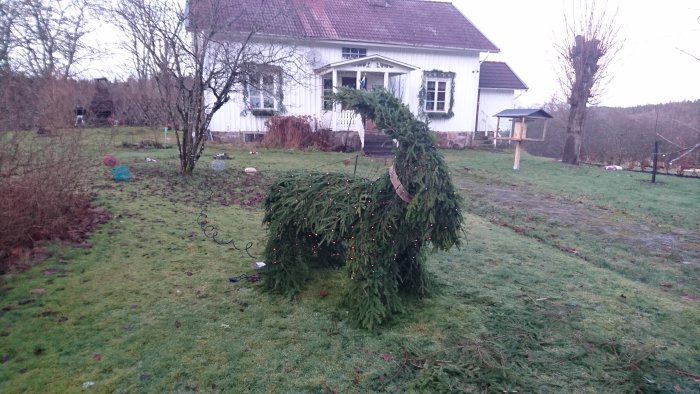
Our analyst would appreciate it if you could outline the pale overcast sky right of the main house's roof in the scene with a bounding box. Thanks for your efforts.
[451,0,700,107]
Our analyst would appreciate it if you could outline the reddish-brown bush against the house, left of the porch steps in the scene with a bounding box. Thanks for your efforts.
[262,116,331,150]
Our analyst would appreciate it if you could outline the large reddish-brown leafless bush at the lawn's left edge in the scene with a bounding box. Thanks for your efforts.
[0,132,107,273]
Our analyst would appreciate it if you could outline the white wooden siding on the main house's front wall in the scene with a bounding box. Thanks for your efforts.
[210,43,482,133]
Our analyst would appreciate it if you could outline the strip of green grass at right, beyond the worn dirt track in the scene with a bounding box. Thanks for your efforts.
[446,151,700,229]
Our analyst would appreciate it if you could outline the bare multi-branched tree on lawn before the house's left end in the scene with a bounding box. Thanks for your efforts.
[112,0,300,174]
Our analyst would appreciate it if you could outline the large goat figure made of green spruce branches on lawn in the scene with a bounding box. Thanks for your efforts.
[263,89,462,329]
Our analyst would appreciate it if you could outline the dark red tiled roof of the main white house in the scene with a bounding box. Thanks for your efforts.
[190,0,498,52]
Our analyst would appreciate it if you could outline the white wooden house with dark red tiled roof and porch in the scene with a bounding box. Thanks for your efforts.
[200,0,524,148]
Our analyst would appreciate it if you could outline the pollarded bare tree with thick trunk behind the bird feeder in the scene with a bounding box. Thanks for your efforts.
[558,0,622,164]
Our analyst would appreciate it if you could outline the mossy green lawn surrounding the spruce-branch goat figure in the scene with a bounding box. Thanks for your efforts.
[0,131,700,393]
